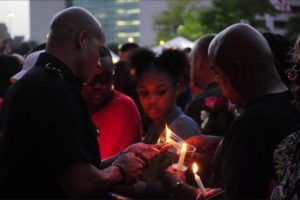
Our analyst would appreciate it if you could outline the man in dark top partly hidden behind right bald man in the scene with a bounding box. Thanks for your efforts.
[184,34,236,136]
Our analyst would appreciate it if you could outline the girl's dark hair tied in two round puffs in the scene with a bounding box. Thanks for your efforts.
[129,48,189,83]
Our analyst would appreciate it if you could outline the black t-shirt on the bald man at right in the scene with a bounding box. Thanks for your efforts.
[211,92,299,199]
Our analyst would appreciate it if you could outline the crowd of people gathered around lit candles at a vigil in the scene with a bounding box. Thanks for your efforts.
[0,7,300,200]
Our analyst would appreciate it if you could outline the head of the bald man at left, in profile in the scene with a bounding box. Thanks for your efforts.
[46,7,105,81]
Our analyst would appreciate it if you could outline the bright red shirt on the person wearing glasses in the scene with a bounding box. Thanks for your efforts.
[92,90,142,159]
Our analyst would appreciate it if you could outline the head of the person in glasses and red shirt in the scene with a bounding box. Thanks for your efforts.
[81,47,114,112]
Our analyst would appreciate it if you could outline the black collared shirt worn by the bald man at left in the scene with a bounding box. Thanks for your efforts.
[0,53,100,198]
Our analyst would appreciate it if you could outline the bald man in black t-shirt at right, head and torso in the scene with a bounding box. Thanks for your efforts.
[208,24,299,198]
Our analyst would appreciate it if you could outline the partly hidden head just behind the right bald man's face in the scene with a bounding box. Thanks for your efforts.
[190,34,215,89]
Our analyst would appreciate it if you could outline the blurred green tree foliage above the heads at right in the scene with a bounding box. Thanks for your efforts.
[154,0,277,40]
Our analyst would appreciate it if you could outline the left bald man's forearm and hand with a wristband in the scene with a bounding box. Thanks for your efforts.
[59,153,145,198]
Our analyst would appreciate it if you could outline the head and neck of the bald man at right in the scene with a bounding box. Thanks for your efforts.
[208,23,287,107]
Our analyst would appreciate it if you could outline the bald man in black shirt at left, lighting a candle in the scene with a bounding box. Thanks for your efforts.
[0,7,158,199]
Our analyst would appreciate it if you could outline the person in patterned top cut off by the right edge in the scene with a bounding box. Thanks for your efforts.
[271,33,300,200]
